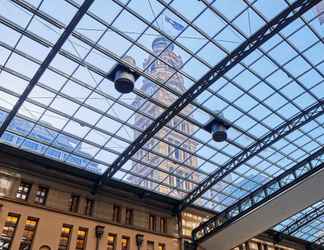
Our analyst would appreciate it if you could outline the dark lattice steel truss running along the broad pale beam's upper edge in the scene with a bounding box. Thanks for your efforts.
[192,147,324,243]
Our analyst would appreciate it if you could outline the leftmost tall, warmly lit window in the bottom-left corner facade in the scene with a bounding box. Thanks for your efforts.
[0,213,20,250]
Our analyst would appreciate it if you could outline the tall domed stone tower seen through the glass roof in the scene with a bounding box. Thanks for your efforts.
[128,37,198,198]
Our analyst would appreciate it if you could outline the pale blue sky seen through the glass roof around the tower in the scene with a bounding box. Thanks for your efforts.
[0,0,324,215]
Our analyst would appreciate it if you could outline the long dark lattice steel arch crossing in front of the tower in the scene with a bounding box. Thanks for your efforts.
[93,0,320,193]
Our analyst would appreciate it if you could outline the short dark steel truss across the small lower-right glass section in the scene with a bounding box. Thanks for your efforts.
[281,205,324,235]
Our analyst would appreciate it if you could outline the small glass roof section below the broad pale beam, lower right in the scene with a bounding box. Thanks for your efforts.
[274,200,324,244]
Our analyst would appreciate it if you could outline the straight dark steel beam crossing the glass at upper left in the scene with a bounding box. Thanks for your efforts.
[0,0,94,137]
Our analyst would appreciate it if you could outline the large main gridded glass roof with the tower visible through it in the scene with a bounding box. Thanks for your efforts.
[0,0,324,218]
